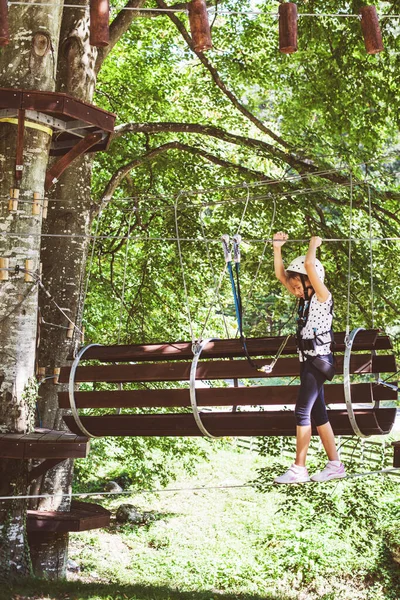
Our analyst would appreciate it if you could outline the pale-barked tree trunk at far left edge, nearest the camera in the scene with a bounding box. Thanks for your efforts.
[0,0,61,581]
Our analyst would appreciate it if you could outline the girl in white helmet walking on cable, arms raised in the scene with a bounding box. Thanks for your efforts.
[273,231,346,483]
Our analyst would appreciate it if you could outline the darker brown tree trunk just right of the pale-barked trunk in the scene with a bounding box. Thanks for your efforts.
[31,1,96,578]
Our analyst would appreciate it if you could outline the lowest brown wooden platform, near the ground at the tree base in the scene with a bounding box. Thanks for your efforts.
[26,500,111,534]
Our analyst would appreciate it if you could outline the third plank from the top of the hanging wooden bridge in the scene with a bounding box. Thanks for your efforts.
[58,383,397,408]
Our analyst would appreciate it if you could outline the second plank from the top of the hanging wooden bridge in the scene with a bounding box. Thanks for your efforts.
[59,354,396,383]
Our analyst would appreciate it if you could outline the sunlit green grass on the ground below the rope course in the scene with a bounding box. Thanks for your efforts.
[5,442,400,600]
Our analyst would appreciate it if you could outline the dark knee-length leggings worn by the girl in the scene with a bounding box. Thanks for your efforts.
[294,354,333,427]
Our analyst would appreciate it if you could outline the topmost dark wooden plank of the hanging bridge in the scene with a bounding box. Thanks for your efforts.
[69,329,392,362]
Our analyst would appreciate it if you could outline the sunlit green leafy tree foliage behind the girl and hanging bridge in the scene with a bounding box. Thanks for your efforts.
[78,0,400,502]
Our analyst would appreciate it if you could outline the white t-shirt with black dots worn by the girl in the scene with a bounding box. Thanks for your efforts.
[299,294,333,361]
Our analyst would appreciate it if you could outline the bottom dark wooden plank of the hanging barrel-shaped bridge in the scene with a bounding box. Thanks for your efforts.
[64,408,396,436]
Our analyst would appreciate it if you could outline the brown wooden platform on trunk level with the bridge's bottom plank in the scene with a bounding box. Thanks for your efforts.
[0,429,90,459]
